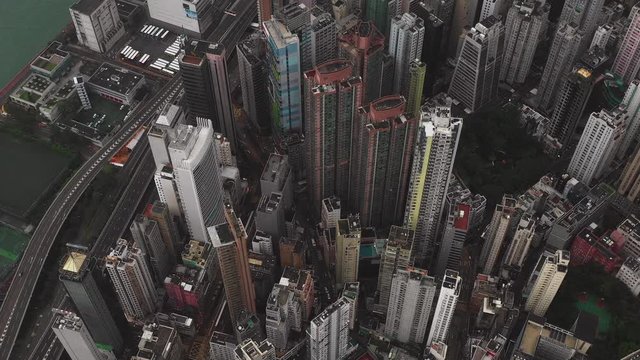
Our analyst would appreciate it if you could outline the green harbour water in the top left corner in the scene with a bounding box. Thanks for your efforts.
[0,0,75,88]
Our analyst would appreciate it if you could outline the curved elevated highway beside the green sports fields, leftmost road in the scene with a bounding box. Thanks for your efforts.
[0,73,182,359]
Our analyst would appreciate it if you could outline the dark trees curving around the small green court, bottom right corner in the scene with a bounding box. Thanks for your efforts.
[547,264,640,360]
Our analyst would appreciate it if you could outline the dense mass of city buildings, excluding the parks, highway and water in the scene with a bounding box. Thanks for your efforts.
[11,0,640,360]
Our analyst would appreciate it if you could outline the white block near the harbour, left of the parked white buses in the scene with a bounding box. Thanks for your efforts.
[69,0,124,53]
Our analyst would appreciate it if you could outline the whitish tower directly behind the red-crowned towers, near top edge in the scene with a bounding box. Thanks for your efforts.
[389,13,424,96]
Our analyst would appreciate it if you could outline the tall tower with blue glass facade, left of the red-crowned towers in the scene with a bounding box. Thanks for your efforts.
[262,20,303,135]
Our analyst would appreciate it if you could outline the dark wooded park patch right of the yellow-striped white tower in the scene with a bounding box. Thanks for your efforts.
[455,104,551,204]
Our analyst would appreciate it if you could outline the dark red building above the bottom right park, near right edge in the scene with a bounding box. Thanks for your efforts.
[570,224,623,273]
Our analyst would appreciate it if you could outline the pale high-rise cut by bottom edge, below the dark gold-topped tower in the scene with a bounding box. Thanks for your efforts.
[52,309,116,360]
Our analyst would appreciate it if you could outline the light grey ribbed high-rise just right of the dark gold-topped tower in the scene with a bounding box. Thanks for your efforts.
[105,239,157,322]
